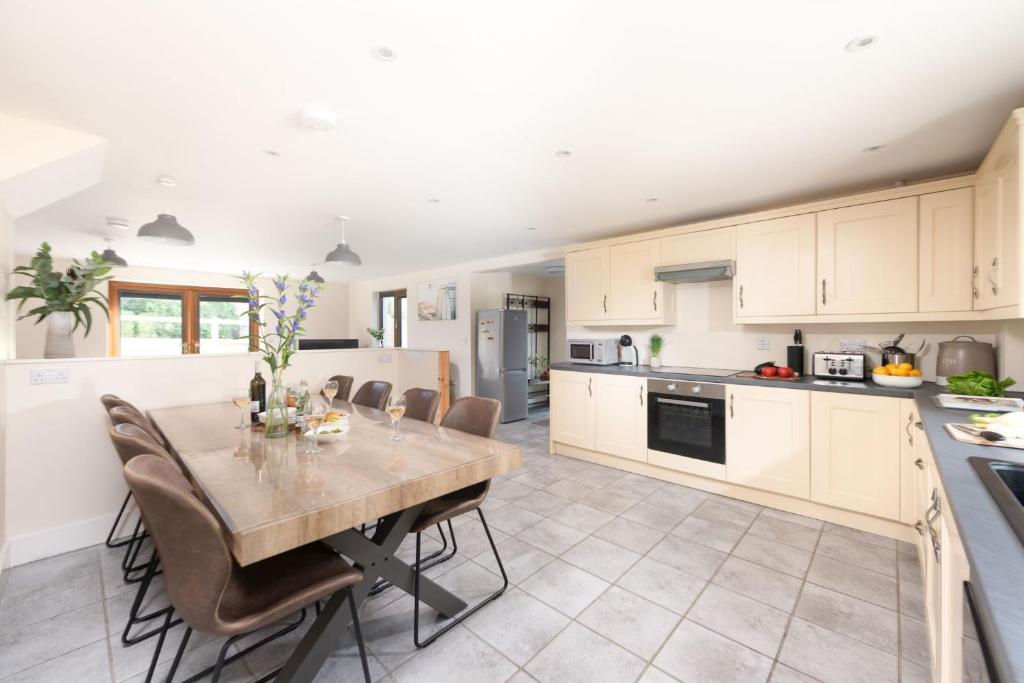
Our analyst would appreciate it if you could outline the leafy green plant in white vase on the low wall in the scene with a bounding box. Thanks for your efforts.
[6,242,113,358]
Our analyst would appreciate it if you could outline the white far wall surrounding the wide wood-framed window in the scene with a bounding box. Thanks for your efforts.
[14,254,348,358]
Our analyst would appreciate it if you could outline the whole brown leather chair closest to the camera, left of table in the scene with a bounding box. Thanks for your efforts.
[125,455,370,683]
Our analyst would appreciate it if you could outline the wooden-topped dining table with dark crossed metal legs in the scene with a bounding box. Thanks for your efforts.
[150,400,522,682]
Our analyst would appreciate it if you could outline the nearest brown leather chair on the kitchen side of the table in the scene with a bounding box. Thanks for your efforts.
[410,396,509,647]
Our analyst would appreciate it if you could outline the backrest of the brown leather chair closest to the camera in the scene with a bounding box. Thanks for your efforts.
[125,455,234,635]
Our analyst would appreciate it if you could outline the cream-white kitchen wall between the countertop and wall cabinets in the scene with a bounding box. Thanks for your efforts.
[567,281,1003,384]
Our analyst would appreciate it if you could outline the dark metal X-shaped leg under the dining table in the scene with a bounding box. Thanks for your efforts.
[275,505,466,683]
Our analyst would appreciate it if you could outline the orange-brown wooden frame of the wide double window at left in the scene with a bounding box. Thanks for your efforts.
[106,281,259,356]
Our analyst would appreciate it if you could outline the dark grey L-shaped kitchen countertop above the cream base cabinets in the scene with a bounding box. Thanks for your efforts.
[551,362,1024,682]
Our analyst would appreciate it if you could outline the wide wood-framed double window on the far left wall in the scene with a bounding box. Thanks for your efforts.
[108,282,256,356]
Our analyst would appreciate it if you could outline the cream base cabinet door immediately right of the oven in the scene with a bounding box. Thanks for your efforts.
[725,385,812,499]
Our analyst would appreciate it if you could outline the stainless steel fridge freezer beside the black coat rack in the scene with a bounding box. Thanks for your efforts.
[476,309,527,422]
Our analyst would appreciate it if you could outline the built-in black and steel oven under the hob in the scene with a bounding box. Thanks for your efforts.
[647,379,725,465]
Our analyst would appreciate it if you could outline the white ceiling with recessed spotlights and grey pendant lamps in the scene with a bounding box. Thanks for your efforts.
[0,0,1024,280]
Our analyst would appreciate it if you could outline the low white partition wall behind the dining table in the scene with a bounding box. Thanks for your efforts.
[0,349,438,564]
